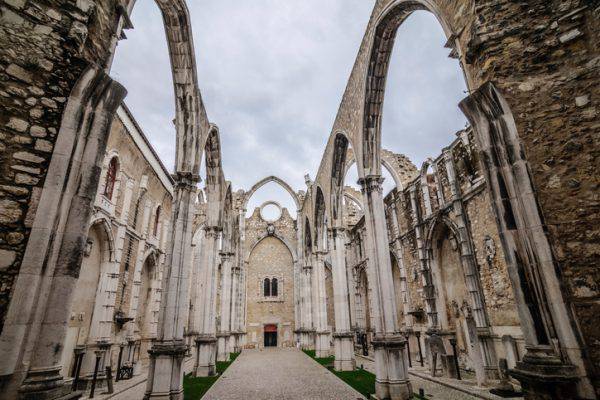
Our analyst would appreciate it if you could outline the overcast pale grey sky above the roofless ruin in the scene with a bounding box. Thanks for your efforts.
[112,0,465,214]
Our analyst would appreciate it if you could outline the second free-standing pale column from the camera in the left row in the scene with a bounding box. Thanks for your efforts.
[194,226,221,376]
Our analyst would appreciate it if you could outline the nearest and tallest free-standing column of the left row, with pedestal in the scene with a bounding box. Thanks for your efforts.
[144,173,195,400]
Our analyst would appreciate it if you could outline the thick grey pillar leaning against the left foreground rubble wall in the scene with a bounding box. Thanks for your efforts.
[9,68,126,400]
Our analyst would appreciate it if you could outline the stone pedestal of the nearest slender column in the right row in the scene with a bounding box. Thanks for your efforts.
[372,335,412,400]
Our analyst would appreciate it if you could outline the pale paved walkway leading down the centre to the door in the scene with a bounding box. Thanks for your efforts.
[202,349,364,400]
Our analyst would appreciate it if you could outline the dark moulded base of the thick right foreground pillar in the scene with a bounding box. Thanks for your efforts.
[509,347,580,400]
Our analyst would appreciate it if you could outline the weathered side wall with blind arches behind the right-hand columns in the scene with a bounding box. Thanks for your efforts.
[347,129,525,380]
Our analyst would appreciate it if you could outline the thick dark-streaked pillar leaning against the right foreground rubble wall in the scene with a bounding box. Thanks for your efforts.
[460,82,595,400]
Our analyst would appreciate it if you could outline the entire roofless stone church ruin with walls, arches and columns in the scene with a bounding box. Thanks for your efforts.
[0,0,600,399]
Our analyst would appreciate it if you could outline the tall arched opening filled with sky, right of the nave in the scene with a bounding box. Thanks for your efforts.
[381,10,467,167]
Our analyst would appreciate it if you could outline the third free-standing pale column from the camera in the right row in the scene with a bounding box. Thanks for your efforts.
[312,251,330,358]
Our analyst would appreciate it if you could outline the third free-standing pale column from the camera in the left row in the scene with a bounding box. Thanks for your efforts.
[217,252,234,361]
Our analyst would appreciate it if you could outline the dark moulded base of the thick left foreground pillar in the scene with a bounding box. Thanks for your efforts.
[19,366,83,400]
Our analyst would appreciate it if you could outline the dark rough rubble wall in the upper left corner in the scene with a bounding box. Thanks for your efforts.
[0,0,116,331]
